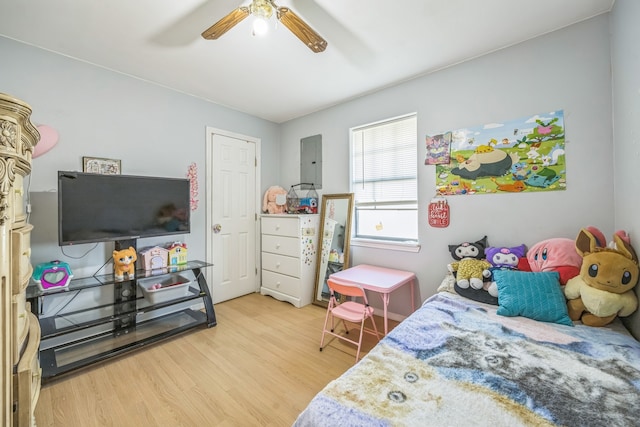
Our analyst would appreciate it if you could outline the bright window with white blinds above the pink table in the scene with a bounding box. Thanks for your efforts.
[351,114,418,243]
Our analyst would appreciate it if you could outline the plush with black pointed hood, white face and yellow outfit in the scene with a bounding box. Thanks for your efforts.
[447,236,491,289]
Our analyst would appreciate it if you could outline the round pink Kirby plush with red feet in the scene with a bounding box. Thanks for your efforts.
[518,237,582,285]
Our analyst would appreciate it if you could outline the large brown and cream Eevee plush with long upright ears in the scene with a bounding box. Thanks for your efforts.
[564,229,640,326]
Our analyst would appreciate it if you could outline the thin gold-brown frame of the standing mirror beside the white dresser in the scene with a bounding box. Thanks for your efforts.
[313,193,353,307]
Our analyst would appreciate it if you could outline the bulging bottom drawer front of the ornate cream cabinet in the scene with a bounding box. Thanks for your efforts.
[14,313,42,426]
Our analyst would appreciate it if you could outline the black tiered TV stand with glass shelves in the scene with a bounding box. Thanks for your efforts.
[26,261,217,382]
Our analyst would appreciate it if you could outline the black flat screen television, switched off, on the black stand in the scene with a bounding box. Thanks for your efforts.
[58,171,191,246]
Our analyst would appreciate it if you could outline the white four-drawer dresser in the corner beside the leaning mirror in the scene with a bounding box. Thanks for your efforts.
[260,214,319,308]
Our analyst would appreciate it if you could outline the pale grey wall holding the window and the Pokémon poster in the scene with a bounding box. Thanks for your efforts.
[282,15,614,314]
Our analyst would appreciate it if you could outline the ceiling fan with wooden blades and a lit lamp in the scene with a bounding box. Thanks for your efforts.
[202,0,327,53]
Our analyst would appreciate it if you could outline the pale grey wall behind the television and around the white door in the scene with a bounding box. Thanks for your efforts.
[0,37,280,274]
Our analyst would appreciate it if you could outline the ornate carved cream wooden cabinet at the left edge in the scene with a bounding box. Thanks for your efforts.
[0,93,41,426]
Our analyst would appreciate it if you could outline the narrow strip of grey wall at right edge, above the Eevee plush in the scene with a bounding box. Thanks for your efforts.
[610,0,640,339]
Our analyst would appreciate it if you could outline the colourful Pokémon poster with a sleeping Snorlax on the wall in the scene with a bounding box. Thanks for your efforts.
[436,110,567,195]
